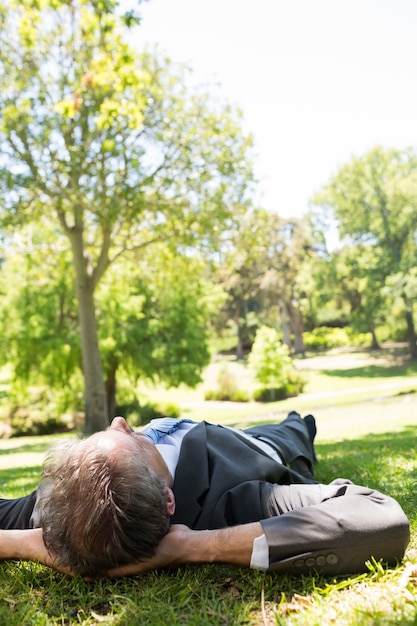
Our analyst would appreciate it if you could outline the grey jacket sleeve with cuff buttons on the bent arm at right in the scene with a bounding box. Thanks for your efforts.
[261,479,410,575]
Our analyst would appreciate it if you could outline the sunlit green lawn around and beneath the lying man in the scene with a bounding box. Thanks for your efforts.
[0,346,417,626]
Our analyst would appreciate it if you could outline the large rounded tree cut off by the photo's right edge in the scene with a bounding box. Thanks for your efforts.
[313,147,417,358]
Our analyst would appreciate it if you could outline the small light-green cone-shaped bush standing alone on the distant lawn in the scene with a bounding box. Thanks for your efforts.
[248,326,305,401]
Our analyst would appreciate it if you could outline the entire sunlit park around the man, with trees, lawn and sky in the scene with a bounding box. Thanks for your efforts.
[0,0,417,624]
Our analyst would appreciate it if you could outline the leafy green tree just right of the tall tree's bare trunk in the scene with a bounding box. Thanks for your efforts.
[97,244,216,415]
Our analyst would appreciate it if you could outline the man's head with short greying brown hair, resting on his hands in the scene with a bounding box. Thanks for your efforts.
[35,418,175,576]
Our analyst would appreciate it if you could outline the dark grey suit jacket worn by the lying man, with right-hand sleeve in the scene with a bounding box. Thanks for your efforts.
[172,414,409,575]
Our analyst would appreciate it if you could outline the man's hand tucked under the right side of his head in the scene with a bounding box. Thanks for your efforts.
[107,524,196,577]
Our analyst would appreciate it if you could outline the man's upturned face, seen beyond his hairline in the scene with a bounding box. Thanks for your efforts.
[89,417,172,487]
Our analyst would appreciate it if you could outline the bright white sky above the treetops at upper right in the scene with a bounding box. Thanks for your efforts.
[138,0,417,217]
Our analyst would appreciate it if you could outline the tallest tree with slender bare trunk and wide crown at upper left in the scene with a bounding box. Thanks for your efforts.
[0,0,252,432]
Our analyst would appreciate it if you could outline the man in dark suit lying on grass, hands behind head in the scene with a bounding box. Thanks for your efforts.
[0,412,409,577]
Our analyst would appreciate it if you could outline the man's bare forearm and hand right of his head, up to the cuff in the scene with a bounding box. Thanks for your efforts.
[108,522,264,576]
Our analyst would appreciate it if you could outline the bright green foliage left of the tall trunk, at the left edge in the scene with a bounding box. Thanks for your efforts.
[0,223,82,410]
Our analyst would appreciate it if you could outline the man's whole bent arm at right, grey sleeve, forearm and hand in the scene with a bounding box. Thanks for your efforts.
[109,481,409,576]
